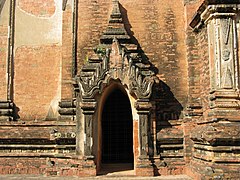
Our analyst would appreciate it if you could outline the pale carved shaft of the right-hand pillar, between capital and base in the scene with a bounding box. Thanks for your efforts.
[213,17,238,89]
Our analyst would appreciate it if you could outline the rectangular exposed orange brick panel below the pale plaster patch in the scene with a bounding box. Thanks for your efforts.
[14,45,61,120]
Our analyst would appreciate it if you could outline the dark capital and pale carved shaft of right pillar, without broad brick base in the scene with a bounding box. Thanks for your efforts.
[190,0,240,115]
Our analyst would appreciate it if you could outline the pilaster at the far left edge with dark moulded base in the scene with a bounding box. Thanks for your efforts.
[0,0,16,121]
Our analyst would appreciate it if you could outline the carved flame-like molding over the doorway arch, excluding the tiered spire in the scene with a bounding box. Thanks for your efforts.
[75,38,157,99]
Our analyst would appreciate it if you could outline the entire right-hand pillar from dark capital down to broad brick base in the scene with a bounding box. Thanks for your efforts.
[190,0,240,179]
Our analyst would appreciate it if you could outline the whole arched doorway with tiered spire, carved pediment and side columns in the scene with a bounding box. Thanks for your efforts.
[74,1,159,175]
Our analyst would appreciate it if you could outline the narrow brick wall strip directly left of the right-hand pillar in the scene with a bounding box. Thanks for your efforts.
[182,0,205,179]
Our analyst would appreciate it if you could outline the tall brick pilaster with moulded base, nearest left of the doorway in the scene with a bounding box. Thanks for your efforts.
[59,0,78,121]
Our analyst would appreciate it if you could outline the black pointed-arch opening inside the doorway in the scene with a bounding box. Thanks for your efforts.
[102,89,133,165]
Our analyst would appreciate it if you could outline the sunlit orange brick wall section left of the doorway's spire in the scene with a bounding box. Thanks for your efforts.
[77,0,112,70]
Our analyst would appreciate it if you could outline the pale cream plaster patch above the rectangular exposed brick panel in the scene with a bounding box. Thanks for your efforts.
[15,0,62,48]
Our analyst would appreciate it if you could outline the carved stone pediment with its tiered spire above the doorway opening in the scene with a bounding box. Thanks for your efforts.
[76,0,157,99]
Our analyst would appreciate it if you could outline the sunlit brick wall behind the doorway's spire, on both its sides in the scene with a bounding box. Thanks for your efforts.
[78,0,188,106]
